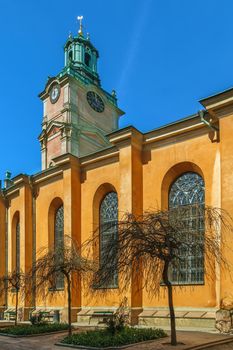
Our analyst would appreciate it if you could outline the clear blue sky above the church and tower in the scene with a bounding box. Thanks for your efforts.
[0,0,233,179]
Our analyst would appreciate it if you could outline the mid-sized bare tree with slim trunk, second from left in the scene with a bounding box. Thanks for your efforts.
[34,236,96,335]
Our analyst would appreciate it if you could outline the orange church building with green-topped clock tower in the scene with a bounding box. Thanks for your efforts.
[0,19,233,329]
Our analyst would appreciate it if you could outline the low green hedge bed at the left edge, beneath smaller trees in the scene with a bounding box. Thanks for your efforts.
[0,323,68,335]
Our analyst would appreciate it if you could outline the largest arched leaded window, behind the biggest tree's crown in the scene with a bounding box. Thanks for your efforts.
[169,172,205,284]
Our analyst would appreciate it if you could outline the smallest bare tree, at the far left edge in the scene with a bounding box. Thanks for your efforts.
[0,270,26,326]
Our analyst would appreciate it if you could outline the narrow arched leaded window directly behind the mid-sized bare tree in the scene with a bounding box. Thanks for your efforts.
[54,205,64,289]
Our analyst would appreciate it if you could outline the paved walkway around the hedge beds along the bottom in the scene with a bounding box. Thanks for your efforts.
[0,331,233,350]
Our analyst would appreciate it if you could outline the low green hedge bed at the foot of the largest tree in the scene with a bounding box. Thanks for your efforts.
[62,327,166,348]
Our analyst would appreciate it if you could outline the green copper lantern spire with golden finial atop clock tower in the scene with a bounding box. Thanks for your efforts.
[64,16,100,86]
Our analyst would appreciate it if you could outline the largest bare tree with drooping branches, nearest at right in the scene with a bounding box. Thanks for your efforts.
[86,205,233,345]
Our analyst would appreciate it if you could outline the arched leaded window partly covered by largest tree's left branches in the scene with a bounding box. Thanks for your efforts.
[100,192,118,288]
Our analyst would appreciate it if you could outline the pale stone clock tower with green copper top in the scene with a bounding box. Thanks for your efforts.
[39,17,124,170]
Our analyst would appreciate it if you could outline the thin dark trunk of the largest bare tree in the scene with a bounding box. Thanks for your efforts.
[163,261,177,345]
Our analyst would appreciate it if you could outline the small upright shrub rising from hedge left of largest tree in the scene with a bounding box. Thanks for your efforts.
[106,297,129,335]
